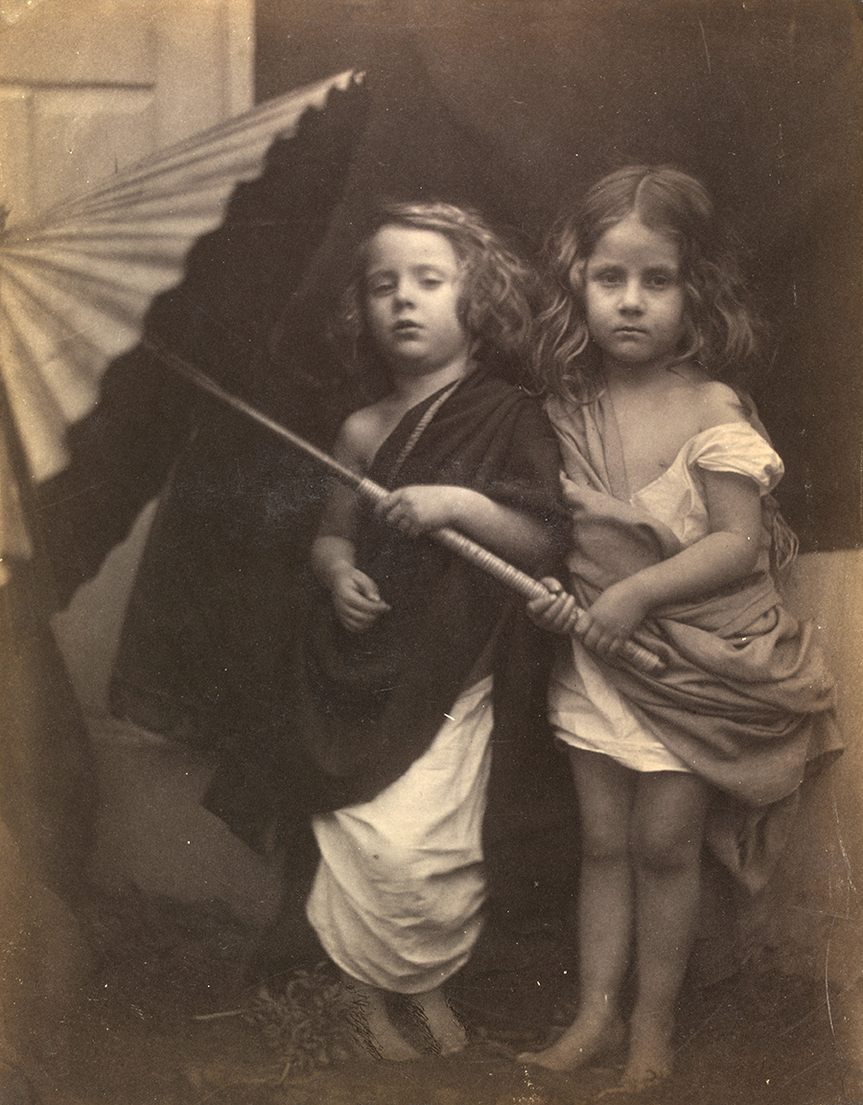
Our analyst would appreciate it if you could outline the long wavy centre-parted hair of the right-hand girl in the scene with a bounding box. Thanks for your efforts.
[530,165,765,402]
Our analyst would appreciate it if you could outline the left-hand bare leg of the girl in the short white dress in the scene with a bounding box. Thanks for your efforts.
[518,748,635,1071]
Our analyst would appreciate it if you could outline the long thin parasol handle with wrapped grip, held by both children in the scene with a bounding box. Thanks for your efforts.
[154,348,665,674]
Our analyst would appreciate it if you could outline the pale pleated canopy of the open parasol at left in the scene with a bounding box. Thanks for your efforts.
[0,72,359,581]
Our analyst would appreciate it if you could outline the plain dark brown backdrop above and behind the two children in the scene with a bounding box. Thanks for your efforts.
[256,0,863,550]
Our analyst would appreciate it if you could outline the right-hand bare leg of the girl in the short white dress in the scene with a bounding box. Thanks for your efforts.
[622,771,709,1091]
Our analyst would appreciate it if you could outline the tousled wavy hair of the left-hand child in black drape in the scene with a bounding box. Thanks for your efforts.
[329,201,538,380]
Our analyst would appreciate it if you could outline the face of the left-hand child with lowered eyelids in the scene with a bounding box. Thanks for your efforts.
[365,225,471,371]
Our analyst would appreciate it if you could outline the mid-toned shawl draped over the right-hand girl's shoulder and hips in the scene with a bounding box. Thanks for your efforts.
[551,397,841,888]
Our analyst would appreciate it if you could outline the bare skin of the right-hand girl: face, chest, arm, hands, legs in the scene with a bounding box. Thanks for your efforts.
[519,214,761,1091]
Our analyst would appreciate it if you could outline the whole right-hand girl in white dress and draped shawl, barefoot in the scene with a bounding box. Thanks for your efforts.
[520,166,836,1091]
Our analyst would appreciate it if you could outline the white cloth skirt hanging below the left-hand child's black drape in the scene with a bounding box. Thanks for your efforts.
[306,676,492,993]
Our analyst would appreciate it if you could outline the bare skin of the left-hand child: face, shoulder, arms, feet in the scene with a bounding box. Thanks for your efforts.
[312,219,551,1060]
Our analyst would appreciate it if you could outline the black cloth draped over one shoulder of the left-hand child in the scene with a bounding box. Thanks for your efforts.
[235,369,577,985]
